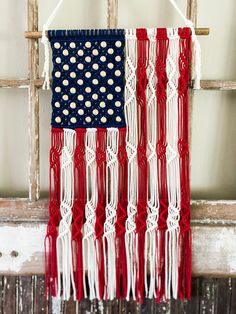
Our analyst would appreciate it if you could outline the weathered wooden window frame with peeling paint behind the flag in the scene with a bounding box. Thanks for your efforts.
[0,0,236,276]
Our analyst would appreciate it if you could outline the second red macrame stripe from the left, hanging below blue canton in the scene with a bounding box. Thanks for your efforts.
[72,128,86,301]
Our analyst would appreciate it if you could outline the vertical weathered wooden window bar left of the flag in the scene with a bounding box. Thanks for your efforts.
[28,0,39,201]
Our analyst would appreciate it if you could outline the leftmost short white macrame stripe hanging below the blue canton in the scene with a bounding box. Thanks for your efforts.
[56,129,76,300]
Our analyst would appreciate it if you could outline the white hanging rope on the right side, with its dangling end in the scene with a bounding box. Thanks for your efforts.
[169,0,202,89]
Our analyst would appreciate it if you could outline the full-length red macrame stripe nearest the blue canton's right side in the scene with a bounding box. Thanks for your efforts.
[136,29,149,303]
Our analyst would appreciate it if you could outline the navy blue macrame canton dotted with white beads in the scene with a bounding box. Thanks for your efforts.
[48,30,125,128]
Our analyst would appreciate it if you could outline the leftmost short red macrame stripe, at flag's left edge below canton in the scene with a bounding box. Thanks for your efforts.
[44,128,63,296]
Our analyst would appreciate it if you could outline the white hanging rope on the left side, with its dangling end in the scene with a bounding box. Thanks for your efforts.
[41,0,63,89]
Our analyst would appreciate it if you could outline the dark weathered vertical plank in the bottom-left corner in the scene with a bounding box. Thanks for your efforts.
[2,276,17,314]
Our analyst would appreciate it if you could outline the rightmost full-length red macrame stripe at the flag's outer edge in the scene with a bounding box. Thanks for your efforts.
[178,28,191,299]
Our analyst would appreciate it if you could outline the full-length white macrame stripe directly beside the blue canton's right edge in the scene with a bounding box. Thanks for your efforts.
[124,29,138,300]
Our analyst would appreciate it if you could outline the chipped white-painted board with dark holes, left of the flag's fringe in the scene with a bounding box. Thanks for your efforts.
[0,224,46,274]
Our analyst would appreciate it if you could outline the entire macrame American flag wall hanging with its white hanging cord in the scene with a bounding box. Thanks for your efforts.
[42,0,200,302]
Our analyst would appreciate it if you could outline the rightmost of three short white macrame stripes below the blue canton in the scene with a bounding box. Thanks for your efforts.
[103,128,119,300]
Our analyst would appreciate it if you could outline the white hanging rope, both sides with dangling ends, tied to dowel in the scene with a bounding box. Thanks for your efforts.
[41,0,201,89]
